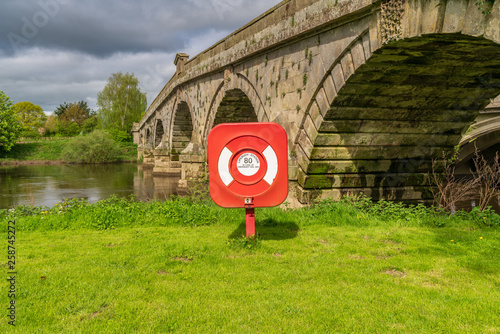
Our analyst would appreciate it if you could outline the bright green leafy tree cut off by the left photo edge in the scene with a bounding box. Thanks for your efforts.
[0,91,22,151]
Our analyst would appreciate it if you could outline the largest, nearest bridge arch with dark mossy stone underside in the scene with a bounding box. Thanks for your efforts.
[297,33,500,200]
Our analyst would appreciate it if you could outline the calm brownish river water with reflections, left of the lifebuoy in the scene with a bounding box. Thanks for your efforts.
[0,164,179,209]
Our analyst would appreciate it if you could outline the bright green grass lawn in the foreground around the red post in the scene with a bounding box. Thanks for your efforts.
[0,198,500,333]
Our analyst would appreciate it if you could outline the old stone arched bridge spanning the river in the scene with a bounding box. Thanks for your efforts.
[134,0,500,203]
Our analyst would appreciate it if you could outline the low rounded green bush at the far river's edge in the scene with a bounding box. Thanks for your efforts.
[62,131,121,164]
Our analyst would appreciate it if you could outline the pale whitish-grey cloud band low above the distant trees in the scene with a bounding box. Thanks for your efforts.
[0,49,180,111]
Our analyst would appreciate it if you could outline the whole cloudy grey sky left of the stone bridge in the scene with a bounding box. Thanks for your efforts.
[0,0,280,113]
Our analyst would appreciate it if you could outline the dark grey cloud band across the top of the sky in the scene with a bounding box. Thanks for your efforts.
[0,0,278,57]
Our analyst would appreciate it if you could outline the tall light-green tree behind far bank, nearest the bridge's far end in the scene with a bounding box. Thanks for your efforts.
[97,72,147,133]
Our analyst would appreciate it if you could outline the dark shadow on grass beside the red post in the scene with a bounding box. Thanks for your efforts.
[229,218,299,240]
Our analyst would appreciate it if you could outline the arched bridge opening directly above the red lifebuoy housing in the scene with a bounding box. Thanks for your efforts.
[213,89,258,126]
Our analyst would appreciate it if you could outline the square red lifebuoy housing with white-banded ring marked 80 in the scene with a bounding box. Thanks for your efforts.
[208,123,288,207]
